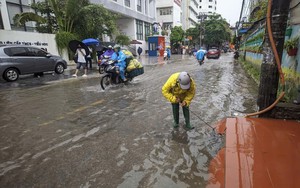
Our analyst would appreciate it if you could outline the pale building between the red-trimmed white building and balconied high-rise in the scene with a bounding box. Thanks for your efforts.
[182,0,199,30]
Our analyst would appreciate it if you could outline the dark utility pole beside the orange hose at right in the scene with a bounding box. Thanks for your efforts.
[257,0,291,117]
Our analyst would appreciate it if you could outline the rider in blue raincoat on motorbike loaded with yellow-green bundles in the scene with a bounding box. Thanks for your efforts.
[111,45,127,81]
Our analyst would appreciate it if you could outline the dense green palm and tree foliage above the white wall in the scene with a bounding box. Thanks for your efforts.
[15,0,117,54]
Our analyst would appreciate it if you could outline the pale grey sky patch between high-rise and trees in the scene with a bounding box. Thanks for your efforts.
[217,0,243,26]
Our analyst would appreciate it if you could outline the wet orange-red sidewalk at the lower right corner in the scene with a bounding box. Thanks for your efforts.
[207,117,300,188]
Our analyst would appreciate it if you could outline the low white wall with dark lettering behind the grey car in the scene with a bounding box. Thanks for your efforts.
[0,30,69,61]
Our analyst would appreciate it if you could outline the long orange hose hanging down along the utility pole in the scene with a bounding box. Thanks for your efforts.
[245,0,285,117]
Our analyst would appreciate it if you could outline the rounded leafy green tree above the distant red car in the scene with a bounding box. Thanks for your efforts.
[202,14,231,46]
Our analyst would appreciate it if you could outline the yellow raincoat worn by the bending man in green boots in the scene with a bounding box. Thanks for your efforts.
[162,72,196,106]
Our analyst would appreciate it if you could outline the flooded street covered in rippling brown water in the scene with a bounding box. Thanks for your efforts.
[0,54,257,188]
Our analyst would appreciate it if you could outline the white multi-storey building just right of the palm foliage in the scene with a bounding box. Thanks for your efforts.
[90,0,156,53]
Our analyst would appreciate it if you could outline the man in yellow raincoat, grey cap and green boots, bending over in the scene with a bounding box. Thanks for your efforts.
[162,72,196,129]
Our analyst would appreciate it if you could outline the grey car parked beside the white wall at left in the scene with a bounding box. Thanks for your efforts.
[0,45,67,82]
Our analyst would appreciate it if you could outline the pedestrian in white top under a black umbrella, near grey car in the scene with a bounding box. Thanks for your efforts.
[69,40,89,77]
